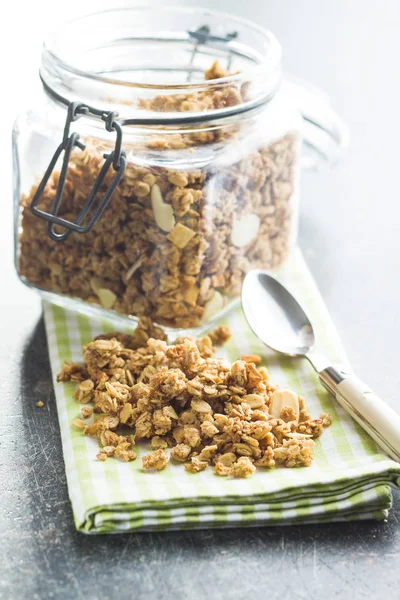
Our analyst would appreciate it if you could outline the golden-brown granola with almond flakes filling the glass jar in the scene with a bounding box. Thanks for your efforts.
[19,59,298,329]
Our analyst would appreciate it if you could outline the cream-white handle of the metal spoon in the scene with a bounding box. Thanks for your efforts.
[319,367,400,462]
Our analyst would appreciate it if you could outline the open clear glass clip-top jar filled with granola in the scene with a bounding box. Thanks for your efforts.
[13,8,346,331]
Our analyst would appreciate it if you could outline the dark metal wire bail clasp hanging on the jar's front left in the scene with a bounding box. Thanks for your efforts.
[31,102,126,242]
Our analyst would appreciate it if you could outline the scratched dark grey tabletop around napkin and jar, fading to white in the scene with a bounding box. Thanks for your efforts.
[0,0,400,600]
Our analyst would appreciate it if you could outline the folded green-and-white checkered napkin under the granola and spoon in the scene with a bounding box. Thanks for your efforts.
[44,251,400,533]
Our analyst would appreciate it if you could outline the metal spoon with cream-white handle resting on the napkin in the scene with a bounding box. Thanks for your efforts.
[242,269,400,462]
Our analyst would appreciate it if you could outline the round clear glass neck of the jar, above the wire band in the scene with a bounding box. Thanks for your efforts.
[40,8,281,124]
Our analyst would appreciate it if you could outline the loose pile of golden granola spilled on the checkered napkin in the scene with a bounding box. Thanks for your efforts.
[58,319,331,477]
